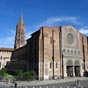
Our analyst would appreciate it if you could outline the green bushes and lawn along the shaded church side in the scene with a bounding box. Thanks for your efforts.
[0,68,36,81]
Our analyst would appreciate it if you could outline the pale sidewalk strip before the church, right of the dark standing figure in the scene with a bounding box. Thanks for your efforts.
[17,77,88,86]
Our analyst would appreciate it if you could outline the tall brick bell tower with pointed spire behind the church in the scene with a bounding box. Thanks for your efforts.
[14,14,26,49]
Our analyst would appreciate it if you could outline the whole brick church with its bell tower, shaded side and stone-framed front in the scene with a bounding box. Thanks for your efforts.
[7,17,88,80]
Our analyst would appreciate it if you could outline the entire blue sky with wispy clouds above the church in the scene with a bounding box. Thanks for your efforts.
[0,0,88,48]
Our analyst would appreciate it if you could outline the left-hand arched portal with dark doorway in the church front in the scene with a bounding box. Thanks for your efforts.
[66,60,73,77]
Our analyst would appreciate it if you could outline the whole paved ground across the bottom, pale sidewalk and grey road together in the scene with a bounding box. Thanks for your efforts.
[0,77,88,88]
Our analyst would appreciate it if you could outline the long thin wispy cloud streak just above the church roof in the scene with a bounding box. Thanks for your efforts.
[35,17,81,28]
